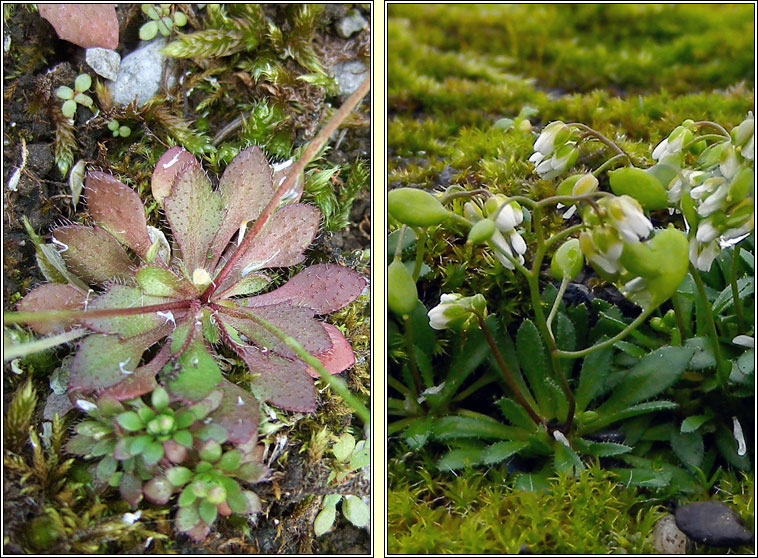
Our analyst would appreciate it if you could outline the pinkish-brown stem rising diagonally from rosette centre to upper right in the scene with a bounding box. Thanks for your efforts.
[200,78,371,304]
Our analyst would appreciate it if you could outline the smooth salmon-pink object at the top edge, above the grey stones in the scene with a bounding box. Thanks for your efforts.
[37,3,118,50]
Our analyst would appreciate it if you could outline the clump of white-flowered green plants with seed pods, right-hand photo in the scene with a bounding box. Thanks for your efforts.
[388,113,754,479]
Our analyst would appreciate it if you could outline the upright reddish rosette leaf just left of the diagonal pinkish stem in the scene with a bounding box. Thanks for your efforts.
[211,146,274,266]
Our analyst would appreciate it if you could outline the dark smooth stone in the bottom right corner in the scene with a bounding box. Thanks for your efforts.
[676,501,753,547]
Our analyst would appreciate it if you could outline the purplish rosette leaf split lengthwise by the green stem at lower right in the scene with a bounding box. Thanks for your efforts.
[218,304,331,358]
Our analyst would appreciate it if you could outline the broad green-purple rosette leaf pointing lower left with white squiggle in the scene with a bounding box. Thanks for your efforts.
[68,325,171,392]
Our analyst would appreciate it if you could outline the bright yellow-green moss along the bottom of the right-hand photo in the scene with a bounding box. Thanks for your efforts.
[388,462,664,555]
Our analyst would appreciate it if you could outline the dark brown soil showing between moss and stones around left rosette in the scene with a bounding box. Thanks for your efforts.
[3,5,371,554]
